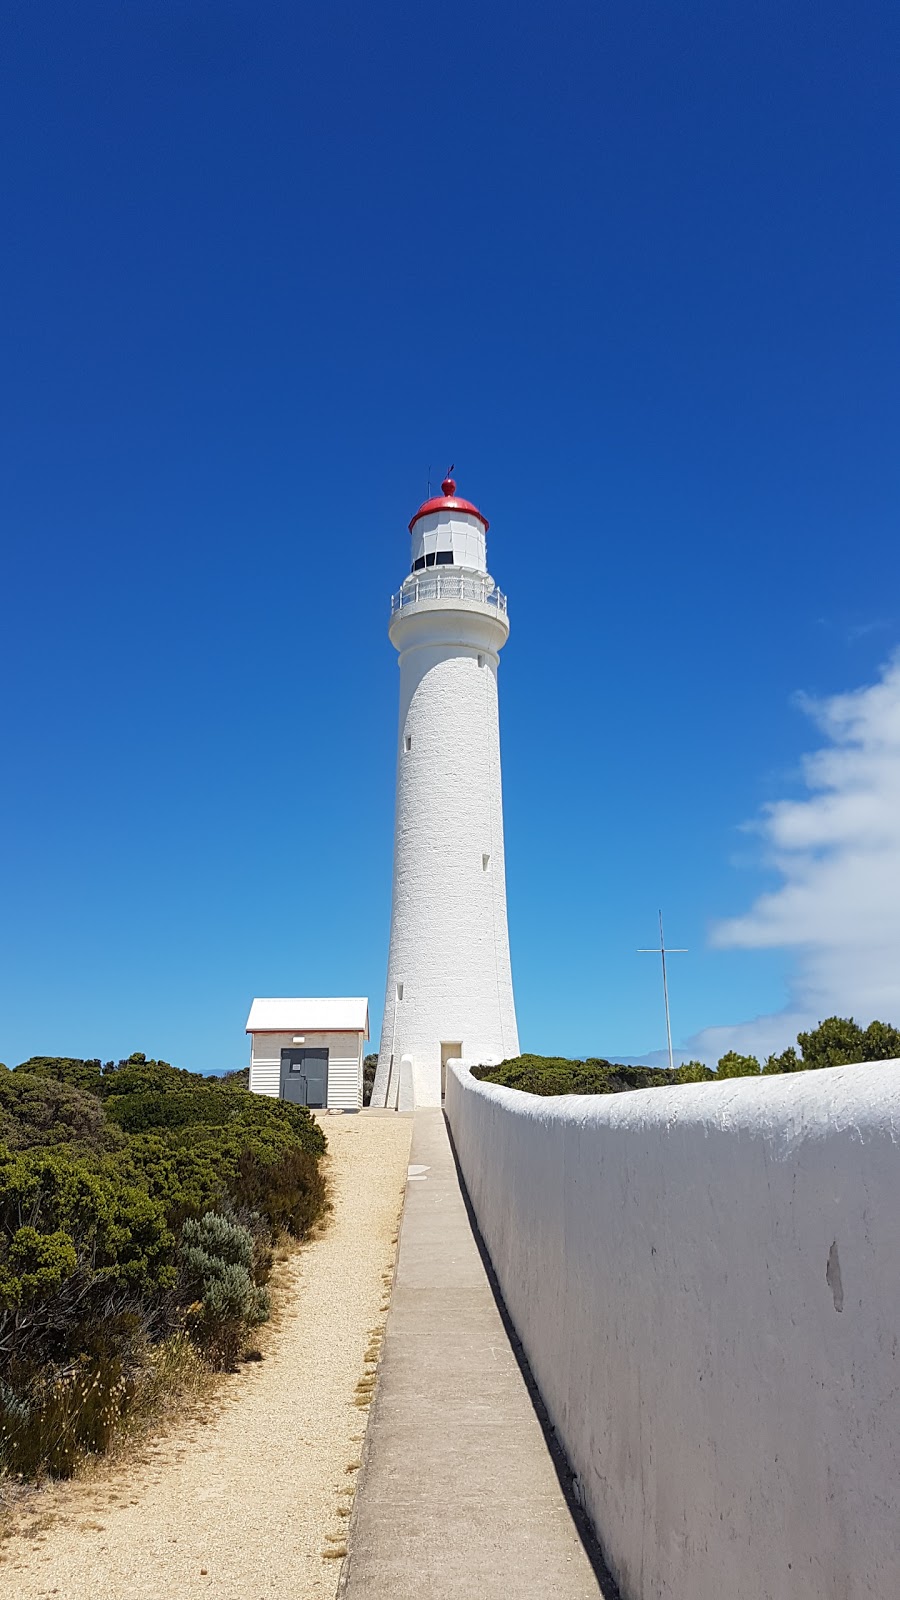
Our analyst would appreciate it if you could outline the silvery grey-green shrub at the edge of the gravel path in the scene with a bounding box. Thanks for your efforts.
[179,1211,269,1366]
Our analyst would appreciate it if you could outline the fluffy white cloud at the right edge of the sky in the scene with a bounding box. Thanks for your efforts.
[690,653,900,1058]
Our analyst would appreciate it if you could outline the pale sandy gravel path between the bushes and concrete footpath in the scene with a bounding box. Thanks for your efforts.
[0,1112,412,1600]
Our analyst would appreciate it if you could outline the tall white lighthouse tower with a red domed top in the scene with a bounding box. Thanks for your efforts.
[372,478,519,1106]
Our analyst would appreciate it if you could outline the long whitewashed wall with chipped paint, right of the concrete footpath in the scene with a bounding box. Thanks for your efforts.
[447,1062,900,1600]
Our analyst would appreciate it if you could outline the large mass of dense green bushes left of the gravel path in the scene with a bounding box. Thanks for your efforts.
[0,1054,325,1480]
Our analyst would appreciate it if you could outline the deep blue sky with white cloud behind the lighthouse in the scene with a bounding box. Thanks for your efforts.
[0,0,900,1070]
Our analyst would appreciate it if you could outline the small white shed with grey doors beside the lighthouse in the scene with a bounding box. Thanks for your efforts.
[247,997,368,1110]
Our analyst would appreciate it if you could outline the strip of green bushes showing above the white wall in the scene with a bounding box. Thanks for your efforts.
[472,1016,900,1094]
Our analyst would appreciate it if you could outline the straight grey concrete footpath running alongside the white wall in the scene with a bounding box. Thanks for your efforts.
[338,1110,615,1600]
